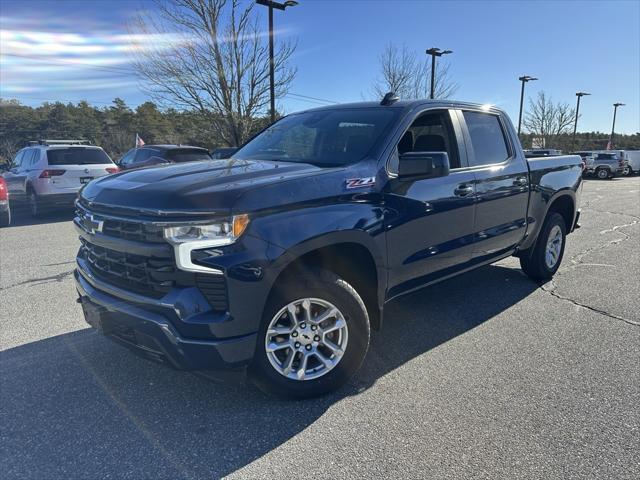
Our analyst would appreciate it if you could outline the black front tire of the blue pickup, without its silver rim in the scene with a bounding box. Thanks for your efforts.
[249,269,370,399]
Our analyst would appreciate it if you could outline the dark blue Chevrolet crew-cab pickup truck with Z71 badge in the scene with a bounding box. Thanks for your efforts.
[74,95,582,398]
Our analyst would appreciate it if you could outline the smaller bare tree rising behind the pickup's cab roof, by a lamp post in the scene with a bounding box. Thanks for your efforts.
[373,43,458,99]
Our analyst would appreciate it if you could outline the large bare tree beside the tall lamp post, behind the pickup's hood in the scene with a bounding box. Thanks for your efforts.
[133,0,296,146]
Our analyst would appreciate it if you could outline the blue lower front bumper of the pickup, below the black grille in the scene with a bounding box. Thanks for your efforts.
[74,266,256,370]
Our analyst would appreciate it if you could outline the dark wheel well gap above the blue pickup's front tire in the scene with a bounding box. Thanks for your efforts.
[274,243,381,330]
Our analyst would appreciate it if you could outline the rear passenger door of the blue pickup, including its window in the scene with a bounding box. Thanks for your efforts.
[459,110,529,264]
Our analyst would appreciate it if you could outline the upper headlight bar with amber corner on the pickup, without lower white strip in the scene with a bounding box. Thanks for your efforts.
[164,215,249,246]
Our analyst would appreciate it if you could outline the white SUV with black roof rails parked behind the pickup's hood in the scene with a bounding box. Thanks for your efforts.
[3,140,118,216]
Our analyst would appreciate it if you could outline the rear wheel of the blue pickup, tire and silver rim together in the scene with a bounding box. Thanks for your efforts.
[520,212,567,280]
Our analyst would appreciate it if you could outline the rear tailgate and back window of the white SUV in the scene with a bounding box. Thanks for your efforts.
[47,146,115,193]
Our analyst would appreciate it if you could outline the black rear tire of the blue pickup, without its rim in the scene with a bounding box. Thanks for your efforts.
[520,212,567,280]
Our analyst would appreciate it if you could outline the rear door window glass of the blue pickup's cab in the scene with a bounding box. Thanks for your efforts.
[463,112,510,166]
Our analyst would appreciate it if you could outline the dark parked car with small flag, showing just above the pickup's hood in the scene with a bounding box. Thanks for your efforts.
[118,145,211,170]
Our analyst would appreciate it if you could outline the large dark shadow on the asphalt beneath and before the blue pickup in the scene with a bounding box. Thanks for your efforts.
[0,266,537,478]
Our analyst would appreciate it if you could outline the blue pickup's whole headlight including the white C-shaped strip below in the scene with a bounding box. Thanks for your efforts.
[164,214,249,274]
